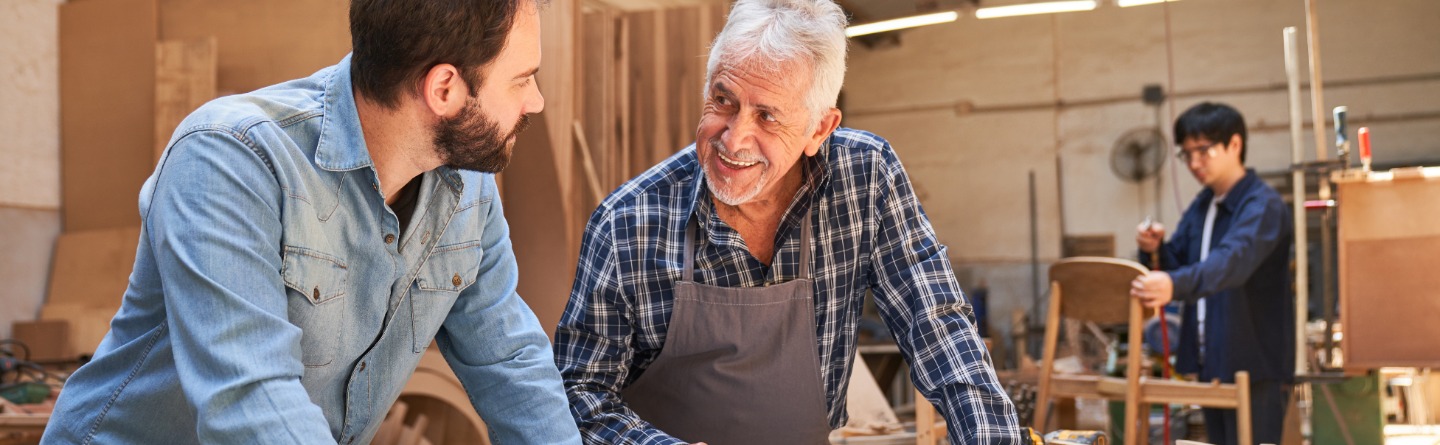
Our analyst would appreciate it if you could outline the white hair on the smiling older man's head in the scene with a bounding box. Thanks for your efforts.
[703,0,850,127]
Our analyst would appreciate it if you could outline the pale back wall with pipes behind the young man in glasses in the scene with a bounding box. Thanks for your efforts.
[844,0,1440,355]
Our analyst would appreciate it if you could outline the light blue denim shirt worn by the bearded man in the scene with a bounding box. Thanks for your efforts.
[45,56,579,444]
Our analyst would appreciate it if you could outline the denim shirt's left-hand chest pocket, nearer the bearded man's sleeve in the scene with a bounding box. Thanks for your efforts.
[281,246,350,367]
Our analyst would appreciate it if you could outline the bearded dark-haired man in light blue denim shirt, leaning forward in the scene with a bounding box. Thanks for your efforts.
[43,0,579,444]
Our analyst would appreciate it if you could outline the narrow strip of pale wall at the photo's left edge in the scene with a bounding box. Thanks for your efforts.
[0,0,60,338]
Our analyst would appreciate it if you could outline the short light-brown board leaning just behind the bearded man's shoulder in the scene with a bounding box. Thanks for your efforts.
[154,37,219,161]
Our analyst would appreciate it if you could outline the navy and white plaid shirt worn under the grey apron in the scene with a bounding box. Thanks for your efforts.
[554,128,1021,444]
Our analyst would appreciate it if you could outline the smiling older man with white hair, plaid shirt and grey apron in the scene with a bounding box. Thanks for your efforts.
[554,0,1022,445]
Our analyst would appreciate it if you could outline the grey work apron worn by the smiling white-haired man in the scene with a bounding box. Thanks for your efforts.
[621,212,831,445]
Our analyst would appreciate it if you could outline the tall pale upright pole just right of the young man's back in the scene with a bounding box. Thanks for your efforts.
[1283,26,1310,376]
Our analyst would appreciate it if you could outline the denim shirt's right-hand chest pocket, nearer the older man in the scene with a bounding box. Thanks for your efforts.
[410,239,485,353]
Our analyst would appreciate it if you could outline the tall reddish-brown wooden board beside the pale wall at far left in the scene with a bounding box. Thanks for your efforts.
[59,0,157,232]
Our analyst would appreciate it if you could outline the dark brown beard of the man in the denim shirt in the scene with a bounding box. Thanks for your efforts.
[435,98,530,173]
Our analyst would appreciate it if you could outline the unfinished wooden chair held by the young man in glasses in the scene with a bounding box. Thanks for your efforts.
[1034,256,1251,445]
